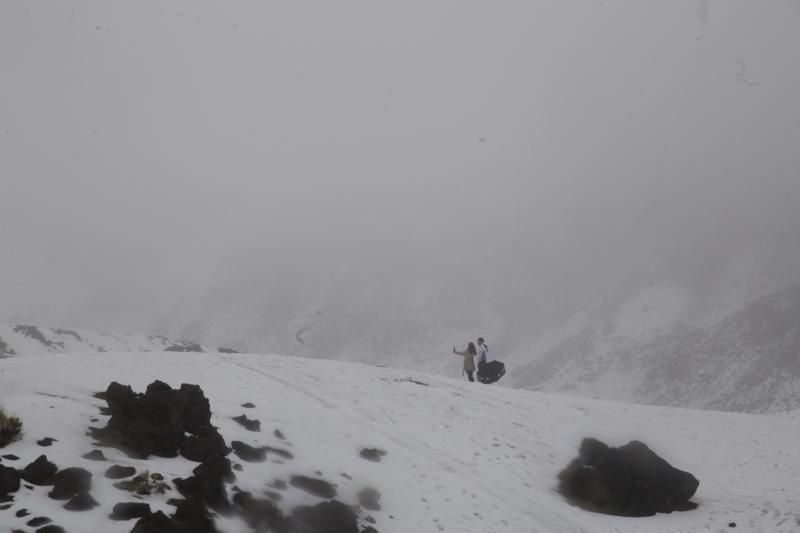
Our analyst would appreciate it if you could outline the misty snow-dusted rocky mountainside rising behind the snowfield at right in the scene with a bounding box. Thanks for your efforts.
[514,285,800,412]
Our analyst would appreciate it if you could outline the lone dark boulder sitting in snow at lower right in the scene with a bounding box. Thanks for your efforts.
[558,438,699,516]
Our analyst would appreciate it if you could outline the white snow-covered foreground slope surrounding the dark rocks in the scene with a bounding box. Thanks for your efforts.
[0,352,800,533]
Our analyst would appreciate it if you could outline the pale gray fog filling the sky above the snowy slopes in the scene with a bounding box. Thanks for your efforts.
[0,0,800,358]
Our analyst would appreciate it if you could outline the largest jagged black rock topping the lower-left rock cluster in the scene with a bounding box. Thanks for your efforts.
[101,381,229,461]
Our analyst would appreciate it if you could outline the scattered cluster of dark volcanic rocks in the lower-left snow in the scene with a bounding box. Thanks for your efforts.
[0,381,385,533]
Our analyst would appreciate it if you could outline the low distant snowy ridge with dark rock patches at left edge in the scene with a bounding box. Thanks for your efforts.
[0,324,233,357]
